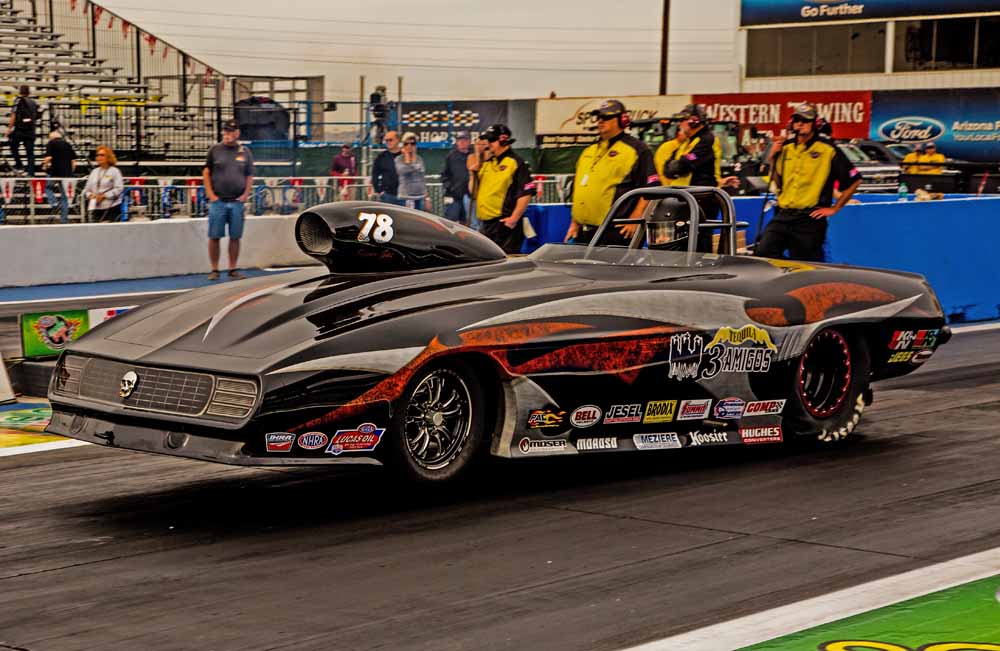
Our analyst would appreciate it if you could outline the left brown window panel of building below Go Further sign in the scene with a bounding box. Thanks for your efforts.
[747,23,885,77]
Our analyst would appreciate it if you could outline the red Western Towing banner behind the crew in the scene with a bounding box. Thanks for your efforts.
[694,91,872,144]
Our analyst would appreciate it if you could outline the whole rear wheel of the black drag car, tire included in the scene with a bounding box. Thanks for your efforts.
[785,328,871,443]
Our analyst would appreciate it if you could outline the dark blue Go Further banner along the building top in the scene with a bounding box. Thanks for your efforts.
[740,0,1000,27]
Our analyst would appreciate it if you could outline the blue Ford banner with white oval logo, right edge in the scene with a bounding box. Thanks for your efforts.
[870,88,1000,162]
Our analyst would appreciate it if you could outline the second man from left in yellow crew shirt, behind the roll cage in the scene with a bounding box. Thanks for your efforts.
[565,99,660,244]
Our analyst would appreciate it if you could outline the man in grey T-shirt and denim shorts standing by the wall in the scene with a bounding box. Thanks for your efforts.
[201,120,253,280]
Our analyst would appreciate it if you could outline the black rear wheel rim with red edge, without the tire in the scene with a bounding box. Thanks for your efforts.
[796,330,854,418]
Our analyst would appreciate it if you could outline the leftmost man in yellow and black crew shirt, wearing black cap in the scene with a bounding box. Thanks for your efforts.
[476,124,535,253]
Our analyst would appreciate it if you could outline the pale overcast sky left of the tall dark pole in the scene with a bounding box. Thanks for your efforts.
[102,0,663,100]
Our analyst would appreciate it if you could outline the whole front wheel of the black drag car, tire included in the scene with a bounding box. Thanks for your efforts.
[387,361,487,483]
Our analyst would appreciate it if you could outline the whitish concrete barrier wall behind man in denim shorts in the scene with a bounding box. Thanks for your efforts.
[0,215,314,287]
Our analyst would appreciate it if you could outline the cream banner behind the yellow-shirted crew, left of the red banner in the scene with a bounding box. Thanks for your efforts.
[535,95,691,148]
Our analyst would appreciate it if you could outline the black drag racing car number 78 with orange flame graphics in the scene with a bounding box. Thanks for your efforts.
[48,188,950,482]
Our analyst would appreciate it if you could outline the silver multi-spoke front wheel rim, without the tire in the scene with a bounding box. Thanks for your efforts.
[403,369,472,470]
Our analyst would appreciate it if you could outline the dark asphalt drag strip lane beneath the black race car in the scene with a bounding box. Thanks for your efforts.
[0,331,1000,651]
